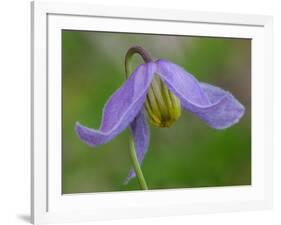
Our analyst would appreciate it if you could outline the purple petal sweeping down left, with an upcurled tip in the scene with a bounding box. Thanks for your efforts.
[75,63,156,147]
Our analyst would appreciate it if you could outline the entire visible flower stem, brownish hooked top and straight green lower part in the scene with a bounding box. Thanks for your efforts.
[125,46,152,190]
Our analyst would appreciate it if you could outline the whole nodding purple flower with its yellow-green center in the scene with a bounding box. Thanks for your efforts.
[75,47,245,188]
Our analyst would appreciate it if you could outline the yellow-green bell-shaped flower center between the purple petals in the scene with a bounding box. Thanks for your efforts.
[145,75,181,127]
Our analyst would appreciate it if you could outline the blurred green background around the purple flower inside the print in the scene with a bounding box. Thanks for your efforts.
[62,30,251,193]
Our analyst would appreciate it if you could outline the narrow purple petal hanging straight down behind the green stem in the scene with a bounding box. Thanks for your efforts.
[125,111,149,183]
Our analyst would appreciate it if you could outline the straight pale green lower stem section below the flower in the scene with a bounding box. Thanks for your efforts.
[130,137,148,190]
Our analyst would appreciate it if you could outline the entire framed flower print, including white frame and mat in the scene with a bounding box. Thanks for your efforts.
[31,1,273,224]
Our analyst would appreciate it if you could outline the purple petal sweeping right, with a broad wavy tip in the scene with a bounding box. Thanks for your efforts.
[156,59,245,129]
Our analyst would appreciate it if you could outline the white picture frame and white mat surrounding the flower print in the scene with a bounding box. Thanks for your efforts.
[31,1,273,224]
